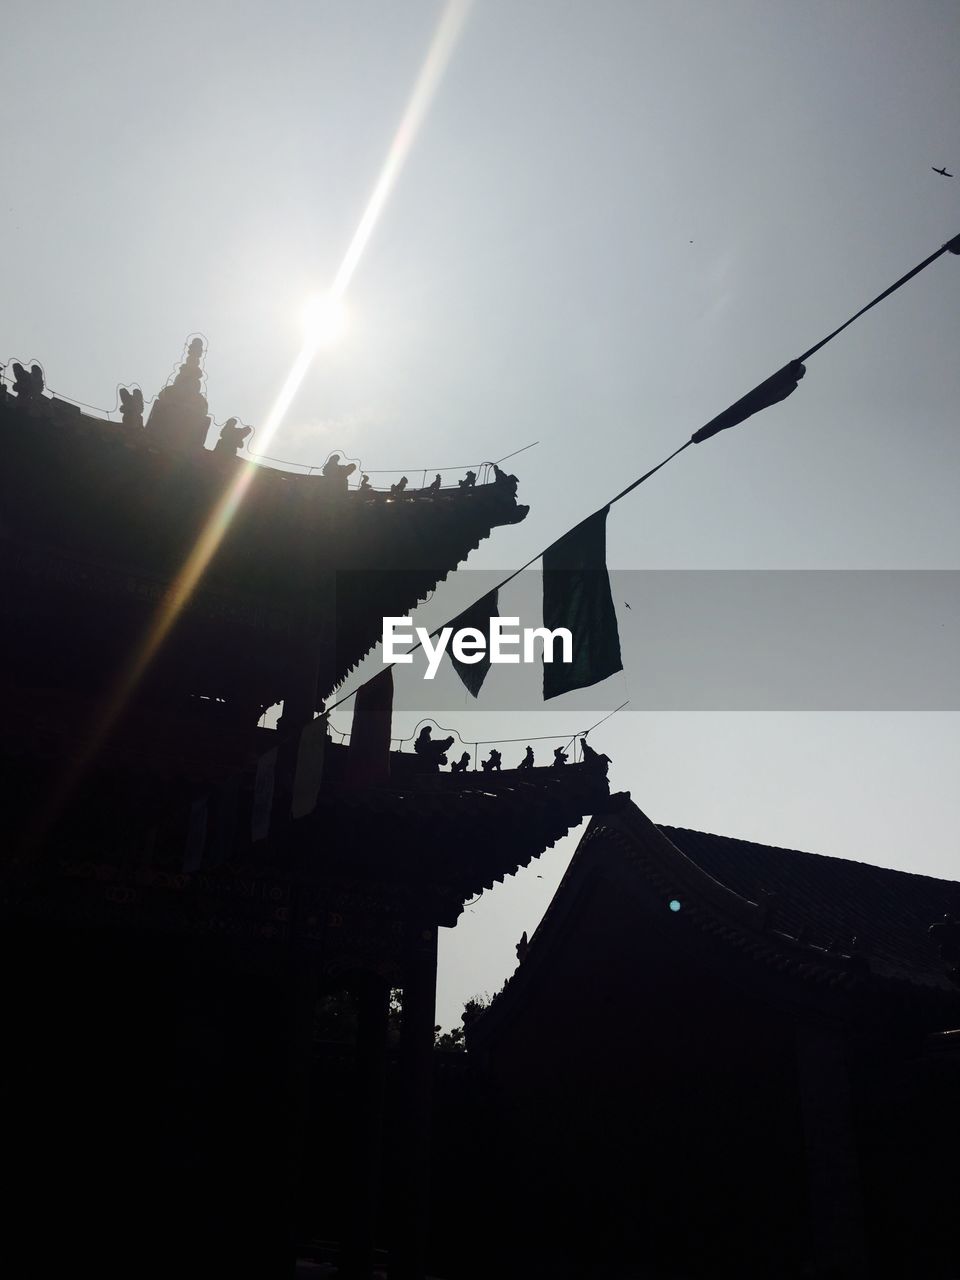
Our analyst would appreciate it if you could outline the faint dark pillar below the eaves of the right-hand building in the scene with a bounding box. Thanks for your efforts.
[797,1025,867,1280]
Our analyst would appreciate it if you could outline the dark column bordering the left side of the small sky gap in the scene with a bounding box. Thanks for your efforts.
[390,924,436,1280]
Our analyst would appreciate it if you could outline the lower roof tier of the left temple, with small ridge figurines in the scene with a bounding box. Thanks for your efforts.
[12,746,609,972]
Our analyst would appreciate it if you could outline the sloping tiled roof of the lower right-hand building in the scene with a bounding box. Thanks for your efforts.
[475,796,960,1039]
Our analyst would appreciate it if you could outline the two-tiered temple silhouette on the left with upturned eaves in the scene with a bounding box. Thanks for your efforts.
[0,339,608,1280]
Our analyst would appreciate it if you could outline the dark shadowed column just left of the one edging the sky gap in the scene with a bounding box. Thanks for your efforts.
[339,973,390,1280]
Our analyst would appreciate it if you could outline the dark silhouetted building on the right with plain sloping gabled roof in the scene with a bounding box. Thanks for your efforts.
[463,796,960,1280]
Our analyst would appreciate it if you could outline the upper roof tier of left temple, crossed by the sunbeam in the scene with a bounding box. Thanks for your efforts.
[0,378,526,707]
